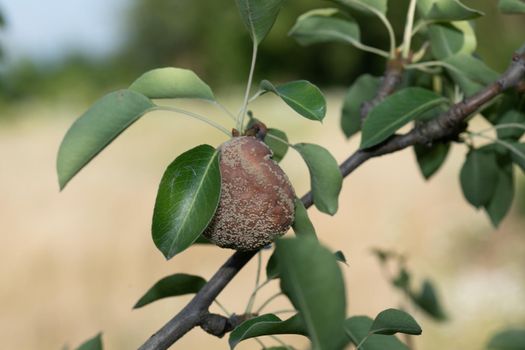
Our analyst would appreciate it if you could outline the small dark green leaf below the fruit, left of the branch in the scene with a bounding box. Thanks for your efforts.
[133,273,206,309]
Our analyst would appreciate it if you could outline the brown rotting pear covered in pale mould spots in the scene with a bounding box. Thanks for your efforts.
[204,136,295,251]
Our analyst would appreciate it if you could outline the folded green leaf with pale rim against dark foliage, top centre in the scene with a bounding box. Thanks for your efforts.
[288,8,361,45]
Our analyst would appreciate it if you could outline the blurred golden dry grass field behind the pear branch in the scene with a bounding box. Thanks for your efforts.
[0,92,525,350]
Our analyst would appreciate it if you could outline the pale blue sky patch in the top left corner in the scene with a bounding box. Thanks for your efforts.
[0,0,127,61]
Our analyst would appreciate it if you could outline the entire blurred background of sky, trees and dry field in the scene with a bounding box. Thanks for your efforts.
[0,0,525,350]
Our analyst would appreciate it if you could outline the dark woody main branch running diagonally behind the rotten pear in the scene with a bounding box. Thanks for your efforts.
[139,47,525,350]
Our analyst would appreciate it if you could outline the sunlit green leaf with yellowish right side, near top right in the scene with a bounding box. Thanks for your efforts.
[428,21,477,60]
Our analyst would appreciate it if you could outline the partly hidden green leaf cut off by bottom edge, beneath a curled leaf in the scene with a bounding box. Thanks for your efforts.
[340,316,409,350]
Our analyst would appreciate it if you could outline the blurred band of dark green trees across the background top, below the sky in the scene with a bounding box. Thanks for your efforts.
[0,0,525,103]
